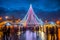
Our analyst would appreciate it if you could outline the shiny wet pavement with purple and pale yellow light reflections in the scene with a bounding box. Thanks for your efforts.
[0,30,46,40]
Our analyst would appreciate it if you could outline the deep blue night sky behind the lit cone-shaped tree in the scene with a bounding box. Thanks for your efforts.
[0,0,60,20]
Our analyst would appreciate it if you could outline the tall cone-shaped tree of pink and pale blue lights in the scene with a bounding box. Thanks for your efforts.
[20,5,43,26]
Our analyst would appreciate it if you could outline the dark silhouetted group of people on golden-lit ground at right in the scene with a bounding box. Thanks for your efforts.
[46,26,58,40]
